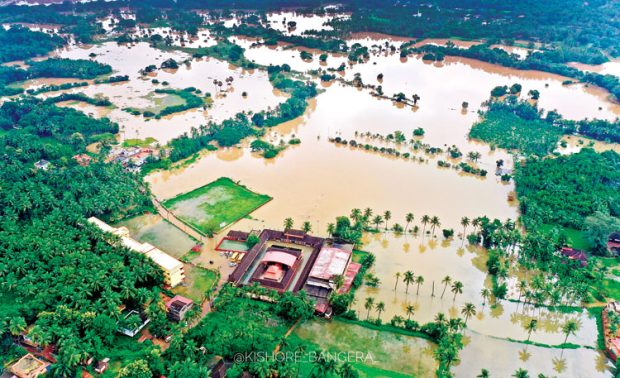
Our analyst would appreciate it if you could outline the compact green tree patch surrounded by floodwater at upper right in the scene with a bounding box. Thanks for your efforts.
[469,110,562,156]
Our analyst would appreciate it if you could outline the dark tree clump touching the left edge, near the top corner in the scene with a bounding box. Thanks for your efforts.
[0,26,66,63]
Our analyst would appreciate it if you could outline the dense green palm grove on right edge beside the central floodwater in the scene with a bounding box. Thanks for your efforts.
[515,149,620,229]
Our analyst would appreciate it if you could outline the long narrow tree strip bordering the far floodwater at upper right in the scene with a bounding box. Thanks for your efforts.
[408,44,620,99]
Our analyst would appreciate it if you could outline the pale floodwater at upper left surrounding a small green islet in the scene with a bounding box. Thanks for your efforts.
[45,42,287,144]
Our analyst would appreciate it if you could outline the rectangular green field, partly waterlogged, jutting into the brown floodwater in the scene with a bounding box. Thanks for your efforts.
[163,177,271,235]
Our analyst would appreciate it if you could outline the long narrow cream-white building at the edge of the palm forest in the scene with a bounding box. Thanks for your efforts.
[88,217,185,287]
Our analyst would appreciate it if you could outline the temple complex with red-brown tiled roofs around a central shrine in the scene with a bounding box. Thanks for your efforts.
[220,230,361,317]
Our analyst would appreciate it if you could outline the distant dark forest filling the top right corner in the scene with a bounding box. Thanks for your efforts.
[332,0,620,64]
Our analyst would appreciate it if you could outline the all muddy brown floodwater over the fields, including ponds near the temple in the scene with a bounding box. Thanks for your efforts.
[3,12,620,377]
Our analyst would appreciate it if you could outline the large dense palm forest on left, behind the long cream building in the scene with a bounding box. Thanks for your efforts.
[0,95,162,376]
